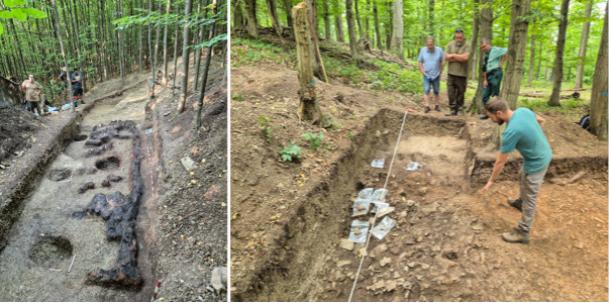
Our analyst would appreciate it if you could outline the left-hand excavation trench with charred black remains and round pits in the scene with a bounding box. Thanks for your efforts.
[0,89,152,301]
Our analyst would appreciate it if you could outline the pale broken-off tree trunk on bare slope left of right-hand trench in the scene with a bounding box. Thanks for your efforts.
[292,0,320,124]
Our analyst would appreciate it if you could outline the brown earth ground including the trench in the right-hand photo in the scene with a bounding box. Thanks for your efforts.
[231,35,608,301]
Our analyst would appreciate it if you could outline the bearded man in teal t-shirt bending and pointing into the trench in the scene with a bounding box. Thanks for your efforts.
[481,97,553,243]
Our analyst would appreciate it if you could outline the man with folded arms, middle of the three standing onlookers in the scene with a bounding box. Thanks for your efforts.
[445,28,470,116]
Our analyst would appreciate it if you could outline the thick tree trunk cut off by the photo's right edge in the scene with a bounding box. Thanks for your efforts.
[591,4,608,140]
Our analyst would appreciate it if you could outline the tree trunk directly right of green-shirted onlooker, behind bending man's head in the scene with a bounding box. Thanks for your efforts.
[500,0,530,109]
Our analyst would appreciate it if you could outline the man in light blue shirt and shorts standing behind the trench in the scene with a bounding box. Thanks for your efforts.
[417,37,443,113]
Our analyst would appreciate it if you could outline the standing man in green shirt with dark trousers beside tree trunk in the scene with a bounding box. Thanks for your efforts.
[481,38,508,119]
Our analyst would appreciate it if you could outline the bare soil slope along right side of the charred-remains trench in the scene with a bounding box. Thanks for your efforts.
[141,57,228,301]
